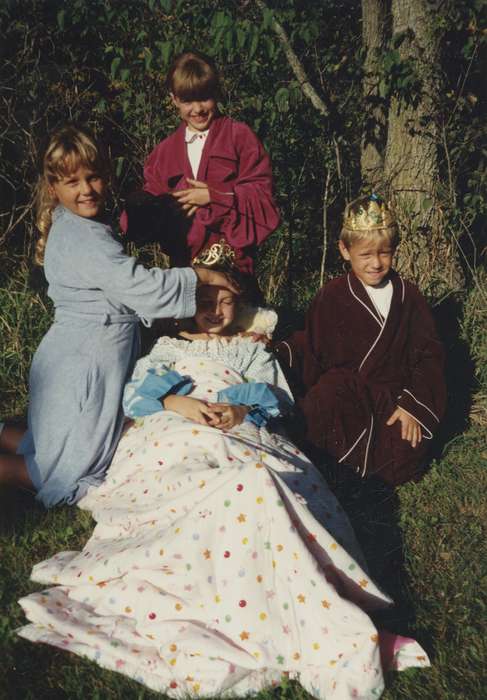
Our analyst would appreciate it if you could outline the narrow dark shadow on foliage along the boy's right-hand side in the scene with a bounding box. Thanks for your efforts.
[430,297,475,459]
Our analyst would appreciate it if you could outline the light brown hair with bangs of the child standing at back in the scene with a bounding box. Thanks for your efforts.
[166,51,220,101]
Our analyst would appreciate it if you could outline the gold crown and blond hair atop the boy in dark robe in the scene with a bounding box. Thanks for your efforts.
[340,194,399,248]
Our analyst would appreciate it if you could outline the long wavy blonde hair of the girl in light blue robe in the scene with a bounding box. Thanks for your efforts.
[35,125,110,265]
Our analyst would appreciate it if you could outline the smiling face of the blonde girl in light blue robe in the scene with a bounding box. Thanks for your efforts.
[49,165,106,219]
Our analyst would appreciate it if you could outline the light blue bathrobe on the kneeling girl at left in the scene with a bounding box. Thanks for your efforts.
[18,206,197,507]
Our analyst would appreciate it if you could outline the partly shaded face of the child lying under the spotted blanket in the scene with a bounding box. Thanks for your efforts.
[194,285,237,335]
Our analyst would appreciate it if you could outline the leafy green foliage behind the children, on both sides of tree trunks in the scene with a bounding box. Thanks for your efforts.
[0,0,487,306]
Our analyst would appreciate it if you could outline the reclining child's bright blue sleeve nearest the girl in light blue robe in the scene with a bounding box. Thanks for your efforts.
[124,369,193,418]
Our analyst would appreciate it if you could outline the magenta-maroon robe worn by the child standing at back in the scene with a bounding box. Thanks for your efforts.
[137,117,279,275]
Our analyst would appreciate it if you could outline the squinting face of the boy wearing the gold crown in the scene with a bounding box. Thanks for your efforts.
[338,237,394,287]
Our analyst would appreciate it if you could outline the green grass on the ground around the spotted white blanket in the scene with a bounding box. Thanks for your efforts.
[0,272,487,700]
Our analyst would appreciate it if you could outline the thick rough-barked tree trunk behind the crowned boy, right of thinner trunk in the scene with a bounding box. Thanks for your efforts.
[384,0,463,298]
